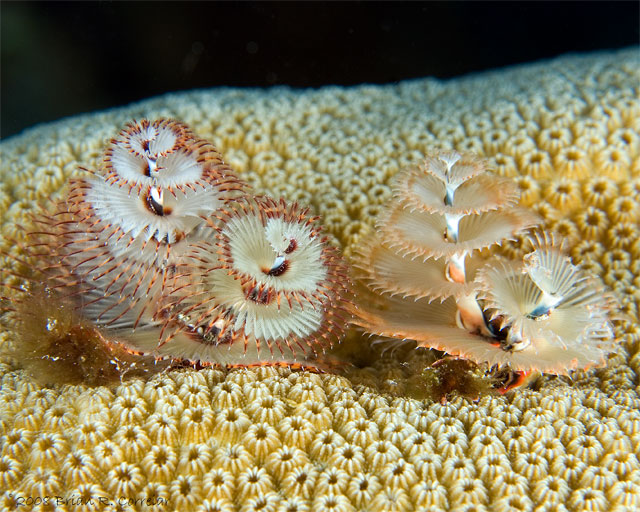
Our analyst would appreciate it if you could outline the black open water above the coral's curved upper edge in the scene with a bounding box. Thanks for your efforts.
[0,0,640,137]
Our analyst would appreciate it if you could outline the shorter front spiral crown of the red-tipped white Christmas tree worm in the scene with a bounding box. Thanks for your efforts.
[151,198,348,364]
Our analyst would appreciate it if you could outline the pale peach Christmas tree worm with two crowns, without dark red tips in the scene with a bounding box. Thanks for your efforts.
[354,152,614,390]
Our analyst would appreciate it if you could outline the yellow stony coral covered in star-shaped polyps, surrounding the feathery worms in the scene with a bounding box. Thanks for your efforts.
[0,48,640,512]
